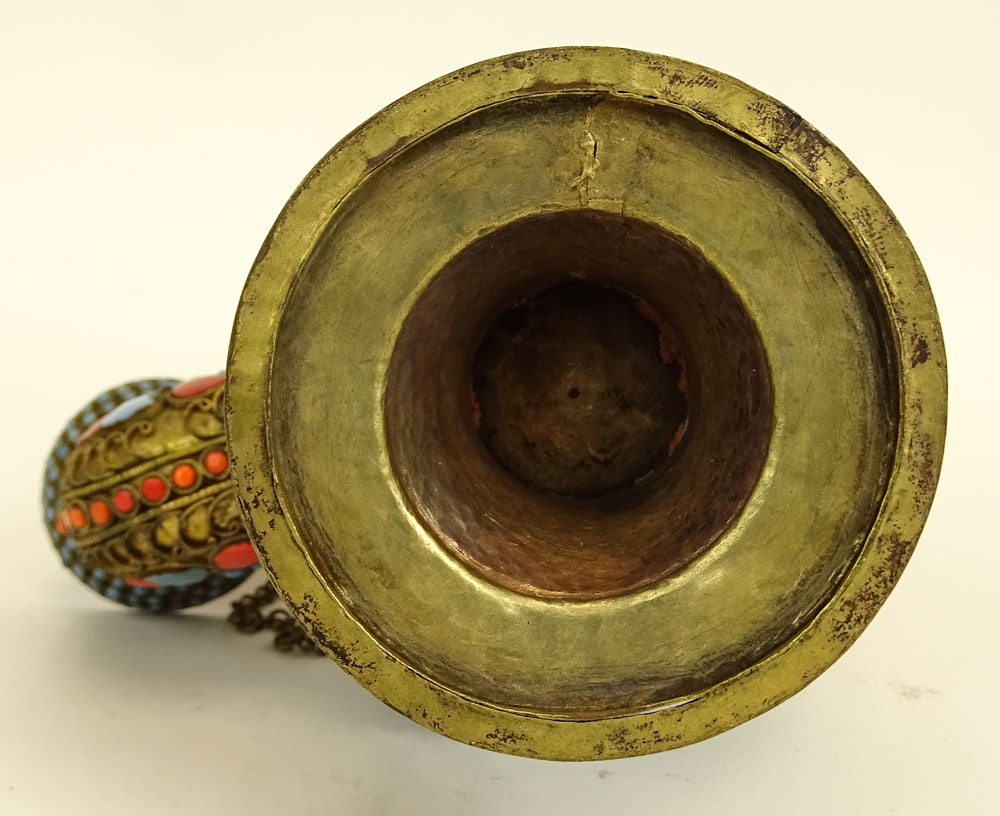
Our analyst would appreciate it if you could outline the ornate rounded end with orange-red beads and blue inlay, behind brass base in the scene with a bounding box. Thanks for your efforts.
[42,374,257,612]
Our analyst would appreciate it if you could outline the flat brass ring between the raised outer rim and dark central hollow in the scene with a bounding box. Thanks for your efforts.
[270,87,892,718]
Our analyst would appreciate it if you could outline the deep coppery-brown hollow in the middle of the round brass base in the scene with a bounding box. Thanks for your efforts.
[384,209,774,600]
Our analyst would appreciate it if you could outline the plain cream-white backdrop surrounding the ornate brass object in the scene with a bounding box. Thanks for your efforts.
[0,0,1000,816]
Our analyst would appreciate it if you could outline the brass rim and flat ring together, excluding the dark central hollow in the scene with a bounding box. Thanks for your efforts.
[227,48,945,759]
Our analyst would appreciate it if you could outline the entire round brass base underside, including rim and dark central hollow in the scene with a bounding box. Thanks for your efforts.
[227,48,945,759]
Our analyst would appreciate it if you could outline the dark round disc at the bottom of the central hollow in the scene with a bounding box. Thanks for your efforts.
[472,281,687,497]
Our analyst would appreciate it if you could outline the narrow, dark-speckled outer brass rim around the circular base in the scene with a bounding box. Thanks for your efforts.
[226,48,946,760]
